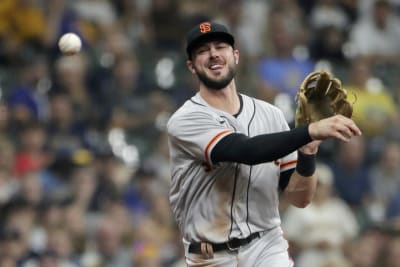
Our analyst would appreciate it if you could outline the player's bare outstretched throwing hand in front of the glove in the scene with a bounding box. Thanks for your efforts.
[308,115,361,142]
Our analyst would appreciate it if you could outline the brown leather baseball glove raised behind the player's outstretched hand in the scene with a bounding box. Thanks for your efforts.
[295,71,353,126]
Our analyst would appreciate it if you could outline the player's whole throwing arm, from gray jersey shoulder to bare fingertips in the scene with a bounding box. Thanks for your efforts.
[168,103,360,173]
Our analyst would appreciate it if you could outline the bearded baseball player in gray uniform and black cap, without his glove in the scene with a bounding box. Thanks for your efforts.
[167,22,361,267]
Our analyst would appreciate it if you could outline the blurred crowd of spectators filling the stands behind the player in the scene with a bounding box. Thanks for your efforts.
[0,0,400,267]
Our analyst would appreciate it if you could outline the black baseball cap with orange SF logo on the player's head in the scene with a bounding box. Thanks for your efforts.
[186,22,235,59]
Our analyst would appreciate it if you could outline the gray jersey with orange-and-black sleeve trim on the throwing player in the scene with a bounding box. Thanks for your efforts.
[167,93,297,246]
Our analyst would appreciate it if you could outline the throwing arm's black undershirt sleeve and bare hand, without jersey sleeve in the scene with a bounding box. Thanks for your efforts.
[211,115,361,165]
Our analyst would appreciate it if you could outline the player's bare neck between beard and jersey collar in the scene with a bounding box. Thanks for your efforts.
[200,80,240,115]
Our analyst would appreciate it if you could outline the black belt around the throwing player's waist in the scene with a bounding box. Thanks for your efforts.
[189,232,261,254]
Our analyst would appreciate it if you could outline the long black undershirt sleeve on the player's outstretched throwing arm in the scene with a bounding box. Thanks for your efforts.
[211,126,312,165]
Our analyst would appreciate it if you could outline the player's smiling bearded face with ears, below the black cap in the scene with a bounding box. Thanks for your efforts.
[188,41,239,90]
